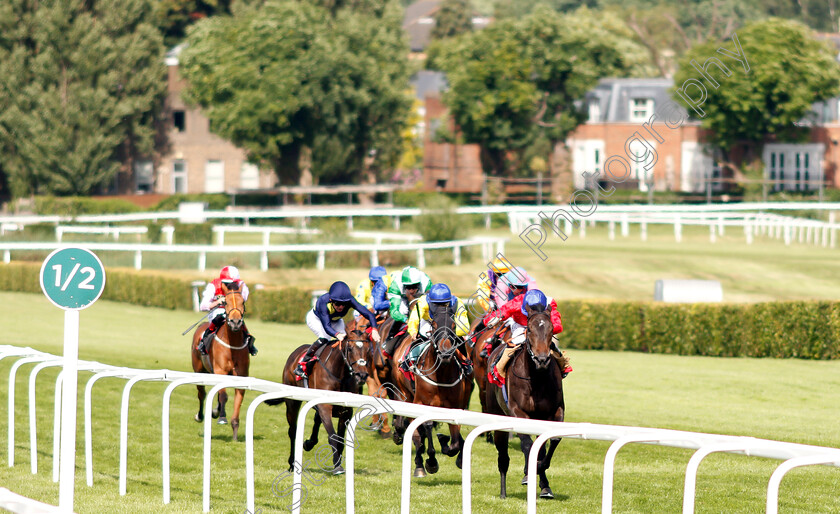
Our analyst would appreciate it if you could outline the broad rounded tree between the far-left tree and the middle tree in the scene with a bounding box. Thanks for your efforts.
[181,0,411,183]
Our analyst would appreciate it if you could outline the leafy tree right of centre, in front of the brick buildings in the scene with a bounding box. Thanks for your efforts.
[436,6,650,175]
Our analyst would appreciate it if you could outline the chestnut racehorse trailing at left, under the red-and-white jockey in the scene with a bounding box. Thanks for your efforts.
[190,283,251,441]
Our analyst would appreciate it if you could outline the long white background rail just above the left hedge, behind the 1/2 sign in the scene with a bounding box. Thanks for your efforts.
[0,237,507,271]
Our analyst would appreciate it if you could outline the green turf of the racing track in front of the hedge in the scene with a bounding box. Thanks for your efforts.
[0,290,840,513]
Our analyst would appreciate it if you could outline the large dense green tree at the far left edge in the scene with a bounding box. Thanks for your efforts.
[0,0,166,196]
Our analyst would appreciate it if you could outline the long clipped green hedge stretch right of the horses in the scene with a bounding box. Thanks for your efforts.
[558,301,840,359]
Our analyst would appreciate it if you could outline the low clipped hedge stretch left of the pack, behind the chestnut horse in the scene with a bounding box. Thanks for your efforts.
[0,262,312,323]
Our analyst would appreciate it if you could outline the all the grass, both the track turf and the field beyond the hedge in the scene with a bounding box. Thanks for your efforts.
[0,224,840,513]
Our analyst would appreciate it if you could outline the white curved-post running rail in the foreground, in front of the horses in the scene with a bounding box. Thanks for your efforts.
[0,345,840,514]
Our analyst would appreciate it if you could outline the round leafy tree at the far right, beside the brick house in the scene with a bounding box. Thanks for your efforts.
[674,18,840,177]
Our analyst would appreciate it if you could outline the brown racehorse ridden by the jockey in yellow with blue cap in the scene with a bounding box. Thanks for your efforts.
[394,303,474,477]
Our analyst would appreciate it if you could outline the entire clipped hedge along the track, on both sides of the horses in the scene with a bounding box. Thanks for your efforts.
[0,262,840,359]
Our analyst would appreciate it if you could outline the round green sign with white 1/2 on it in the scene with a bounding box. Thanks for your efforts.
[41,248,105,310]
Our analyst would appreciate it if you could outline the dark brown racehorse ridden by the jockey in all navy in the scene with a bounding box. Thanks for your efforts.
[276,329,370,475]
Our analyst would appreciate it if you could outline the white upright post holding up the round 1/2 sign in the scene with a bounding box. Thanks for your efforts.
[58,310,79,512]
